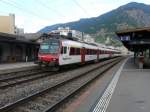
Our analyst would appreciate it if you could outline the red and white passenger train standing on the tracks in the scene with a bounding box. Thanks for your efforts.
[38,38,121,66]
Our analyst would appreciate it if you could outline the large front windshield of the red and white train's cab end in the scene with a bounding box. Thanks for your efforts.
[39,40,60,54]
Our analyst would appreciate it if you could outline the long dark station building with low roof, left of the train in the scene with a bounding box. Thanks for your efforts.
[0,33,39,63]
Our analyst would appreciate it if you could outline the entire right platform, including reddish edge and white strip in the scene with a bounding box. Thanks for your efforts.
[64,57,150,112]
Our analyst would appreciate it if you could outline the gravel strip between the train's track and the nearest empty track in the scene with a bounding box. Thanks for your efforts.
[0,57,119,107]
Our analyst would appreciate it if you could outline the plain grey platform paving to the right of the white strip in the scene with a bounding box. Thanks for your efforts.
[106,58,150,112]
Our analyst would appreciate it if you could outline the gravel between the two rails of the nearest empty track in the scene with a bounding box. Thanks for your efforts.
[11,59,120,112]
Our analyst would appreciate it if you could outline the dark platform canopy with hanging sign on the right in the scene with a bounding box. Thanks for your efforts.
[116,27,150,51]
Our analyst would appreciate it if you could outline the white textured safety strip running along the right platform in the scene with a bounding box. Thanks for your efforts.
[93,59,128,112]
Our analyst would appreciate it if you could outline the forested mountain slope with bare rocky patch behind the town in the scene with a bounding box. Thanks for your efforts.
[39,2,150,45]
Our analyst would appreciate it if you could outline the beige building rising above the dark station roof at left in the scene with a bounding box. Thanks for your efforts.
[0,14,24,34]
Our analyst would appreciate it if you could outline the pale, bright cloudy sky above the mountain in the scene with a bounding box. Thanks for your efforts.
[0,0,150,33]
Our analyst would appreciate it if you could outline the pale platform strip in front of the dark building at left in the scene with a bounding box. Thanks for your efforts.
[0,62,38,74]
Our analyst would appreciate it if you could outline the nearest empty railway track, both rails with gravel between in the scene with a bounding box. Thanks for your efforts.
[0,58,121,112]
